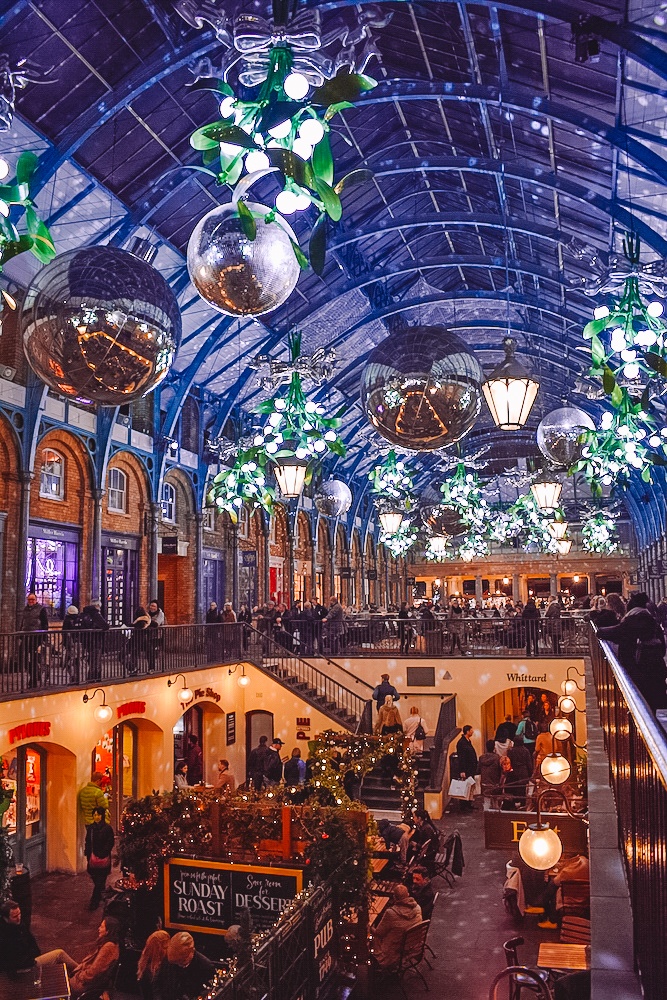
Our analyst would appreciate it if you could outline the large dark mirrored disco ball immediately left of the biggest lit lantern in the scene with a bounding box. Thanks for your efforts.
[361,326,484,451]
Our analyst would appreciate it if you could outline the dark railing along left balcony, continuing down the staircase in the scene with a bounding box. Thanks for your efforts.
[0,623,370,732]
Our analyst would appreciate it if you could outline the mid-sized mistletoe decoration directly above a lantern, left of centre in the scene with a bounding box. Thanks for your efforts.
[253,333,345,483]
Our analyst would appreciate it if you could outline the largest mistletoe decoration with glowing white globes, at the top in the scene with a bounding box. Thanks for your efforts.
[190,15,377,274]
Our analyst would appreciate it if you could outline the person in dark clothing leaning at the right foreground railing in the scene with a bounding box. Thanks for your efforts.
[598,593,667,712]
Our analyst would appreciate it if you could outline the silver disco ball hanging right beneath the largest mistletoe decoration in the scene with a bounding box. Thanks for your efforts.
[188,202,300,316]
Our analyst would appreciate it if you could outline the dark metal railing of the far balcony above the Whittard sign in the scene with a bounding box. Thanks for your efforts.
[324,611,588,659]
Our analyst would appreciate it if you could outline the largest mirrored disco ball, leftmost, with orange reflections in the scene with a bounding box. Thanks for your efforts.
[21,246,181,406]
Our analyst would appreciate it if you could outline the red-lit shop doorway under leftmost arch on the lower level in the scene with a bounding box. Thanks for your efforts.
[2,746,46,875]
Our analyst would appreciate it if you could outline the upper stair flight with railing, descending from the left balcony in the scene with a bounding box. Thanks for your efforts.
[245,629,372,733]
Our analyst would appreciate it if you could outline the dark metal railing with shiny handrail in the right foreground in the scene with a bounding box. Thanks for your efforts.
[591,633,667,1000]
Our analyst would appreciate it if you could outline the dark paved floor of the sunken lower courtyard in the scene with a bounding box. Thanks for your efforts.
[26,803,557,1000]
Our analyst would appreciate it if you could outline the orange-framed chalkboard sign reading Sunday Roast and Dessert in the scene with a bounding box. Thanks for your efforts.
[164,858,303,934]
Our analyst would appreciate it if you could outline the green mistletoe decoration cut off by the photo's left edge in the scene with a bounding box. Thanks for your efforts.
[0,151,56,296]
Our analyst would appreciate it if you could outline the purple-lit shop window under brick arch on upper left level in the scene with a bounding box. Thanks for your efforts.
[25,522,81,621]
